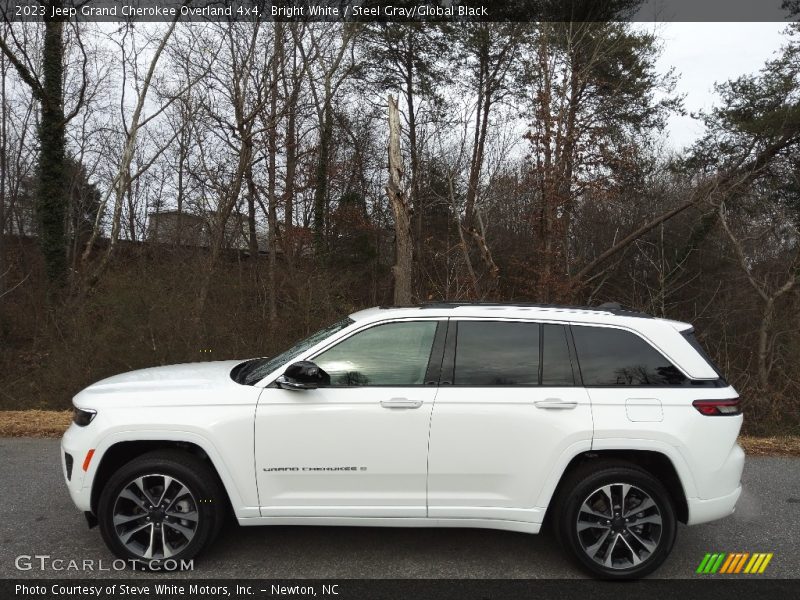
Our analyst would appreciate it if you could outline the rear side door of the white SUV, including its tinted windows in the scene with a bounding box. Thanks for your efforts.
[428,319,592,522]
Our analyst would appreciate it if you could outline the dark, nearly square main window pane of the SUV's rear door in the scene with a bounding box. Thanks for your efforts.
[453,321,539,386]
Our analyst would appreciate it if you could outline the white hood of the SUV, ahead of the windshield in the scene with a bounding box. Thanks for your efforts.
[74,360,250,406]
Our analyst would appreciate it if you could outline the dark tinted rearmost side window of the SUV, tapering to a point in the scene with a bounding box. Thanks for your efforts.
[572,325,687,386]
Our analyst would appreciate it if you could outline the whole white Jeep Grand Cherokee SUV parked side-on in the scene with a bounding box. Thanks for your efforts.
[62,303,744,578]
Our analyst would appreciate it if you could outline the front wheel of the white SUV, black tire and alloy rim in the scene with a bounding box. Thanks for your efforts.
[97,450,227,570]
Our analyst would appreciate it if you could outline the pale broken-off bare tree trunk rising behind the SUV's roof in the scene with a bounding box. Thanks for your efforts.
[386,94,414,306]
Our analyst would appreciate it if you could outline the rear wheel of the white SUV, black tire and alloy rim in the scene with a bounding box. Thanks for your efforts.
[553,460,677,579]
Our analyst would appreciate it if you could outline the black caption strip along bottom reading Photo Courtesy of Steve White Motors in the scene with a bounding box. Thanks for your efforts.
[0,575,798,600]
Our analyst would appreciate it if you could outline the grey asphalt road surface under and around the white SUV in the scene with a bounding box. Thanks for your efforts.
[0,438,800,579]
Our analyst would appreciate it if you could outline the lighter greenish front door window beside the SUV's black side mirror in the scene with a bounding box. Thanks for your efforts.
[312,321,436,387]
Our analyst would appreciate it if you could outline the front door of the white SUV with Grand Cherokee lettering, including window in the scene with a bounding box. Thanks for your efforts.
[255,319,443,517]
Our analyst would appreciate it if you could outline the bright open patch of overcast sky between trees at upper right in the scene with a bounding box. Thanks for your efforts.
[642,23,786,150]
